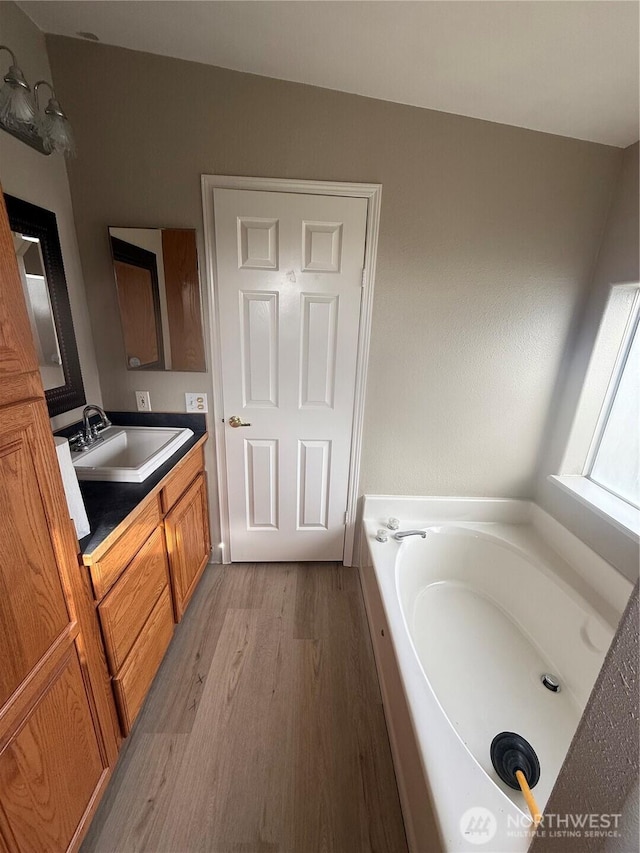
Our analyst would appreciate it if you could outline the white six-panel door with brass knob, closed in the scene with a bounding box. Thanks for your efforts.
[214,189,367,562]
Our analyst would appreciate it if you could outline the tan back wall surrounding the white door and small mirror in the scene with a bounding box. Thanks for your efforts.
[47,36,622,496]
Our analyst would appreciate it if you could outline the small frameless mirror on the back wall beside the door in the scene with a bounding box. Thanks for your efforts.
[109,228,206,372]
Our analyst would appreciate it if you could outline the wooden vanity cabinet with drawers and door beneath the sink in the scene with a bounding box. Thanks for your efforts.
[84,446,211,736]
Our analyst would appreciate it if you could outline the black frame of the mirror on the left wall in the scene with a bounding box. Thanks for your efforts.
[4,193,87,418]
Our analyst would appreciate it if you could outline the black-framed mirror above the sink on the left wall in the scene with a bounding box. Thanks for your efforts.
[4,195,86,417]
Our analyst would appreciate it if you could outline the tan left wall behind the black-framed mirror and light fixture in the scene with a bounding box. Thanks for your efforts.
[0,3,102,429]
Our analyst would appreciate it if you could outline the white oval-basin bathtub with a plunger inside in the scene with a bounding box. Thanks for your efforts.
[361,497,631,853]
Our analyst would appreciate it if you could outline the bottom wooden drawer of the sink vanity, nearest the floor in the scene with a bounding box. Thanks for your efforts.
[113,585,173,735]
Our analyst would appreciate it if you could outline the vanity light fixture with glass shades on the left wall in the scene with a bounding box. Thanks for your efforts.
[0,45,76,157]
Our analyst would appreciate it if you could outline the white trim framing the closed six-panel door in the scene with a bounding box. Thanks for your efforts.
[201,175,382,566]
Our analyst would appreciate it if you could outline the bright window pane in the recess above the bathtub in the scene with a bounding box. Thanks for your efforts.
[586,302,640,507]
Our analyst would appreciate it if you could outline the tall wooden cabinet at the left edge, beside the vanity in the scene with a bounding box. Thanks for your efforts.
[0,192,120,853]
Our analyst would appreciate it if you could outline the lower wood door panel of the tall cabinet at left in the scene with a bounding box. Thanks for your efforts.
[0,646,108,853]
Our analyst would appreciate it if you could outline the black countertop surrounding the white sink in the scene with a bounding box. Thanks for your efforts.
[57,412,206,555]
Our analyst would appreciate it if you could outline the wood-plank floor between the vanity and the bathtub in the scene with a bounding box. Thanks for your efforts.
[82,563,407,853]
